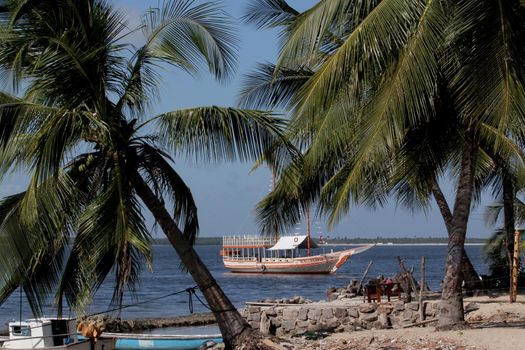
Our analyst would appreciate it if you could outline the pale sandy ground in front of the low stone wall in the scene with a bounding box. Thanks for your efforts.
[282,293,525,350]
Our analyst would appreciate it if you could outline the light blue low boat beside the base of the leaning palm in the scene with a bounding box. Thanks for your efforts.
[101,333,222,350]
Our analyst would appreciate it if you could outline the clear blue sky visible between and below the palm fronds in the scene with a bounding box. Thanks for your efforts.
[0,0,498,237]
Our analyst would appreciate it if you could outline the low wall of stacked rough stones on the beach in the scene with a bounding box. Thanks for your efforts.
[244,301,438,336]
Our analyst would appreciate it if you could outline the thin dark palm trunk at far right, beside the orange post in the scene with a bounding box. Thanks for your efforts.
[502,168,515,292]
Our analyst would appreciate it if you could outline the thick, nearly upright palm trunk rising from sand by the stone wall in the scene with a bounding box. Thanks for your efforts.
[438,138,477,329]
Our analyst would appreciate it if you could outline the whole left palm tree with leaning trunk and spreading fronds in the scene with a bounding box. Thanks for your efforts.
[0,0,283,349]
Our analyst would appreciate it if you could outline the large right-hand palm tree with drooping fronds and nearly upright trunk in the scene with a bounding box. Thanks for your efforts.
[243,0,525,328]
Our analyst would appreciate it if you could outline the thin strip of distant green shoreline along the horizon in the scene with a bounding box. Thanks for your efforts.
[151,236,487,245]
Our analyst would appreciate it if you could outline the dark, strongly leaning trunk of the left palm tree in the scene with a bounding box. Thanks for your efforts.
[130,172,254,348]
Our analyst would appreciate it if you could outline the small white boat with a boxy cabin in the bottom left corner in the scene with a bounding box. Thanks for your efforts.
[0,318,115,350]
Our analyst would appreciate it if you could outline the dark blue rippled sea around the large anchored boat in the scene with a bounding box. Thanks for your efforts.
[0,245,487,329]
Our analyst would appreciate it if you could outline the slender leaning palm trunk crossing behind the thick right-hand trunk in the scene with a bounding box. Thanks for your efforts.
[431,179,480,290]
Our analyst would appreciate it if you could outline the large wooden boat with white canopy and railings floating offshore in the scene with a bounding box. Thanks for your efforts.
[221,235,373,274]
